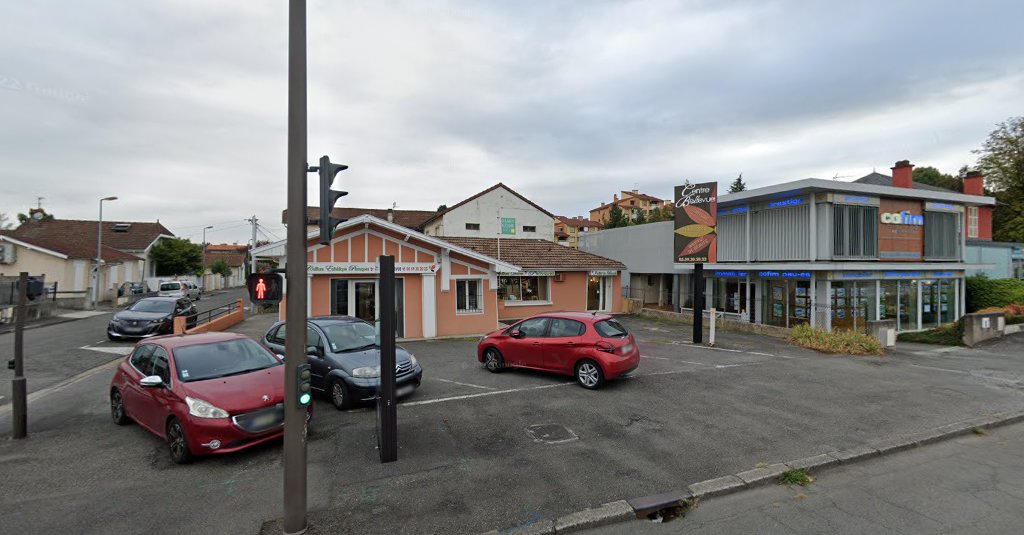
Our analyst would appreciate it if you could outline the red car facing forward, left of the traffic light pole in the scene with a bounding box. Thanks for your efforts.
[110,332,312,464]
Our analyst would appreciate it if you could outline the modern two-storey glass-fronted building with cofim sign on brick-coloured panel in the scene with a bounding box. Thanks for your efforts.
[700,161,995,331]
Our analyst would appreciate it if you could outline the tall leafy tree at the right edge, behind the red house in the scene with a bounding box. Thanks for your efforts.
[974,116,1024,242]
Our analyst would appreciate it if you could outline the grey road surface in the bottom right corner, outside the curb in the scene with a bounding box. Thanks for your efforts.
[586,423,1024,535]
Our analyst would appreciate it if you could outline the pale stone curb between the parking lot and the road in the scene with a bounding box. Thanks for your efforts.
[484,410,1024,535]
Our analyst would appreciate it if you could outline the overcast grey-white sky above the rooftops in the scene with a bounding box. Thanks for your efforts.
[0,0,1024,243]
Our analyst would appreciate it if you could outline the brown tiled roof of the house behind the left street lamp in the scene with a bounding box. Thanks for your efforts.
[10,219,174,251]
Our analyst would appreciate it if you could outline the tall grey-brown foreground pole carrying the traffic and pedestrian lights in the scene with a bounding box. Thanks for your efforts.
[284,0,307,535]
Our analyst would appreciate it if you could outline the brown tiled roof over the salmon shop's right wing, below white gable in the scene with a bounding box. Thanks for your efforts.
[438,236,626,270]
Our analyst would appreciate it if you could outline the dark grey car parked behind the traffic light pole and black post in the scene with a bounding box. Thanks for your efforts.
[263,316,423,410]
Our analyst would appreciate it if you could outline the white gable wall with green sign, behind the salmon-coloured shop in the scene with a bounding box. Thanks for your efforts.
[425,188,555,242]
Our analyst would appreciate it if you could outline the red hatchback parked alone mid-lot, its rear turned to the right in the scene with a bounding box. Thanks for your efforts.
[476,313,640,389]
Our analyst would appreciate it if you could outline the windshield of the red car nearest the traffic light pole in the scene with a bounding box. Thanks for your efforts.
[174,338,282,382]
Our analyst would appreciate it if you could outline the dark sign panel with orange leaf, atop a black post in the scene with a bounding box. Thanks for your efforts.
[673,182,718,263]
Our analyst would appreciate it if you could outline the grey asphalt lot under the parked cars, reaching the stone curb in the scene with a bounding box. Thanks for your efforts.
[0,317,1024,533]
